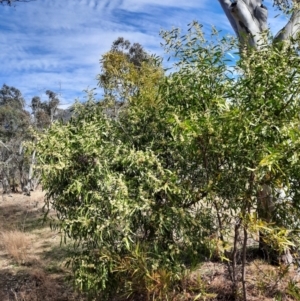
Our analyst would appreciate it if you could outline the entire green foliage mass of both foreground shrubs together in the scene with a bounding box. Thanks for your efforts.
[37,22,300,300]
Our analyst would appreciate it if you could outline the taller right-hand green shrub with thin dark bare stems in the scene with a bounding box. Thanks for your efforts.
[162,24,300,300]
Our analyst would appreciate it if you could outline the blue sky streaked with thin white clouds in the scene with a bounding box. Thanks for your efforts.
[0,0,286,107]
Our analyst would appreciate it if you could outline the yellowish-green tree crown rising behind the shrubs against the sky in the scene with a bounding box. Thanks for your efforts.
[98,38,164,115]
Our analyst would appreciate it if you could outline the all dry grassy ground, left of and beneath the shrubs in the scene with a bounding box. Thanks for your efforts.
[0,190,300,301]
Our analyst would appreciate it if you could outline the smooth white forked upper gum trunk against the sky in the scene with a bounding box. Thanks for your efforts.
[219,0,300,48]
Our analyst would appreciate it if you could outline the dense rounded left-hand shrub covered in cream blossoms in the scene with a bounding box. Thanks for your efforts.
[37,95,210,295]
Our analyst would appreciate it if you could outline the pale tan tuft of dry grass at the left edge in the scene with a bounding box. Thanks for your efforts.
[0,230,32,264]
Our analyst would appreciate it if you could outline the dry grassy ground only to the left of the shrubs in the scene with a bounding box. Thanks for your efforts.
[0,190,85,301]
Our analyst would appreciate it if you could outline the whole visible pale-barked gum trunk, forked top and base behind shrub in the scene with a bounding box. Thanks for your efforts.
[218,0,300,264]
